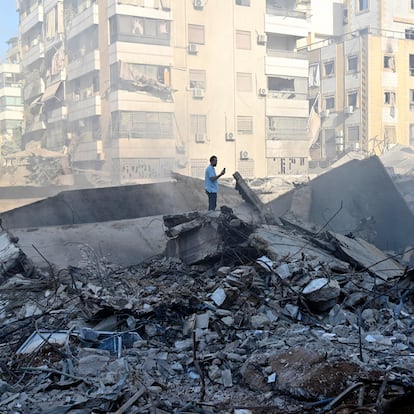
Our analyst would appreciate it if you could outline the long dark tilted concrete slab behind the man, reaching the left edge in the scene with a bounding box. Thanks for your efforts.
[1,175,242,229]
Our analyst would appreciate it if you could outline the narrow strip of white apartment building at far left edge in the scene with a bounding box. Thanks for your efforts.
[0,37,23,157]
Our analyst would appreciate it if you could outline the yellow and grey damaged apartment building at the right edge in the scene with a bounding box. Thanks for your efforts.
[309,0,414,166]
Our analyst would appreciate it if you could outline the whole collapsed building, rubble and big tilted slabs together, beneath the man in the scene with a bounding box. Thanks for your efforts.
[0,157,414,414]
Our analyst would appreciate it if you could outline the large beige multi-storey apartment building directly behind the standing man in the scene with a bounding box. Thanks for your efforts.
[16,0,310,184]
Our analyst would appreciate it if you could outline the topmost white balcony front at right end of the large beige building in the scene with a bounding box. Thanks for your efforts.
[265,9,311,38]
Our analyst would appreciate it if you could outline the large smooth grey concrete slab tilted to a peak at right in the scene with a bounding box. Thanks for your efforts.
[269,157,414,251]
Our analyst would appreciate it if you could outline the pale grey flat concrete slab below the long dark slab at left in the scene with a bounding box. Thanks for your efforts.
[11,216,167,269]
